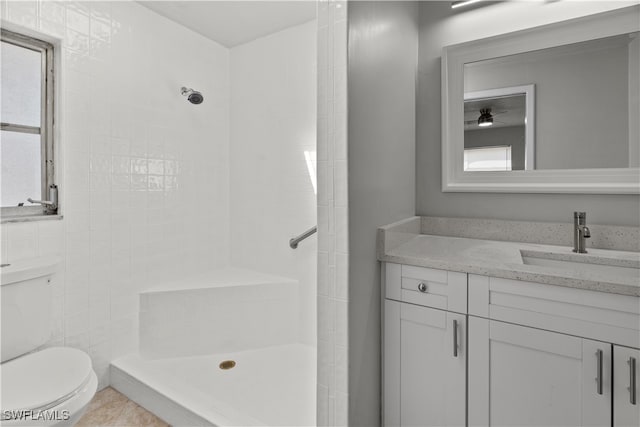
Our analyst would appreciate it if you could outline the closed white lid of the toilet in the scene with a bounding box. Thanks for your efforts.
[0,347,91,410]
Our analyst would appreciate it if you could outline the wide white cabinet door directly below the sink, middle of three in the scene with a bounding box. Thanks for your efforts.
[469,316,612,426]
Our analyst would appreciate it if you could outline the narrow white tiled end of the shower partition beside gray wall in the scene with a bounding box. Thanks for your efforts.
[317,0,349,426]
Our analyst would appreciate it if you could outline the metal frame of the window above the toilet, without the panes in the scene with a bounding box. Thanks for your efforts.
[0,28,57,220]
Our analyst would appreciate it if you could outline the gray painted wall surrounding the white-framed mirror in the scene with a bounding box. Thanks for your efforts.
[416,1,640,226]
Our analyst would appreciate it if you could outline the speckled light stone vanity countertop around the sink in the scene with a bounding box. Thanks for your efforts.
[378,217,640,297]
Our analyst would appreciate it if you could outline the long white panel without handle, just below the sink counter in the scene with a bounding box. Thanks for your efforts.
[469,274,640,347]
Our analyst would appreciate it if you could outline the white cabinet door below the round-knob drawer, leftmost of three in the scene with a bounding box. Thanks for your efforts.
[384,300,466,427]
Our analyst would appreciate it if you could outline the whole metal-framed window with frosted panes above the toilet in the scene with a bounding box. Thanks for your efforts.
[0,29,57,217]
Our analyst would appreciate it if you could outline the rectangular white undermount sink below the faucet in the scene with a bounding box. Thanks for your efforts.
[520,251,640,279]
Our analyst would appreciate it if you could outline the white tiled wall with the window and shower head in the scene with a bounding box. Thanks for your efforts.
[0,0,229,388]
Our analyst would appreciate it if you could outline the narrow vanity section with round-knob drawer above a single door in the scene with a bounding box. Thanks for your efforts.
[383,263,467,426]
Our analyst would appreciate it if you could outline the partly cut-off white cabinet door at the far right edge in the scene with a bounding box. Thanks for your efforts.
[613,346,640,427]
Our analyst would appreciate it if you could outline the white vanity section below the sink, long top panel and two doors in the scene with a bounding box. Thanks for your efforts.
[467,274,640,427]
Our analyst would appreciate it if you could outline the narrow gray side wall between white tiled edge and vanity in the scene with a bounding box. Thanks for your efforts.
[348,1,418,426]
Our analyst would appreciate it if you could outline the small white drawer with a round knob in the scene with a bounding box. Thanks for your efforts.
[384,263,467,313]
